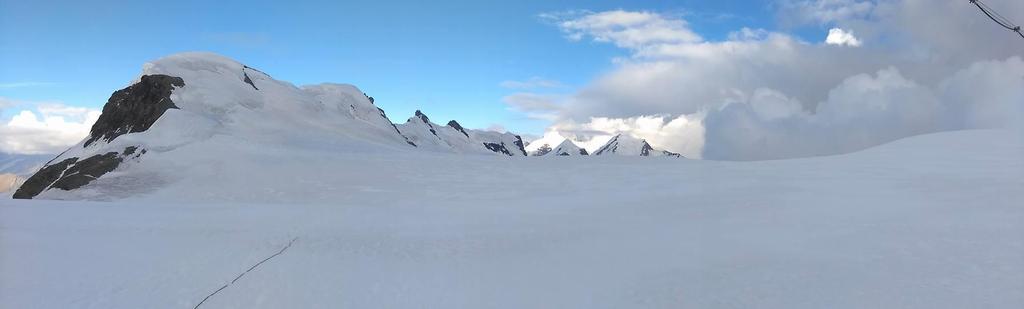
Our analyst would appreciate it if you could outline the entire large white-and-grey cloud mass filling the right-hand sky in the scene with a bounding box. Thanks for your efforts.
[524,0,1024,160]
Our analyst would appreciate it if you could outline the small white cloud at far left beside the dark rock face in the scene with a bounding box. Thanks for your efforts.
[0,98,100,153]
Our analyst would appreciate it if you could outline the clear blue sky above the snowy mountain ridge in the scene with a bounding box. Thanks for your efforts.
[0,0,790,134]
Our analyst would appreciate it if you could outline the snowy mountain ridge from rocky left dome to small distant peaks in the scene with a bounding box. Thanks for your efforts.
[11,52,679,198]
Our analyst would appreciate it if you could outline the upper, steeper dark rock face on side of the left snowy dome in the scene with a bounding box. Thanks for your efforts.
[85,75,185,146]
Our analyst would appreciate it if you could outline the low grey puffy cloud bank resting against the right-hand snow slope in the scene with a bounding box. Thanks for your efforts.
[703,57,1024,160]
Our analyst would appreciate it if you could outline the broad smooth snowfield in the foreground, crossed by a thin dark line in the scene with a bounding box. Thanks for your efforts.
[0,128,1024,308]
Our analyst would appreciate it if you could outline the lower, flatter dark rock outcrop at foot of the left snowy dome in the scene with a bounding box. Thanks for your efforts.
[13,146,145,200]
